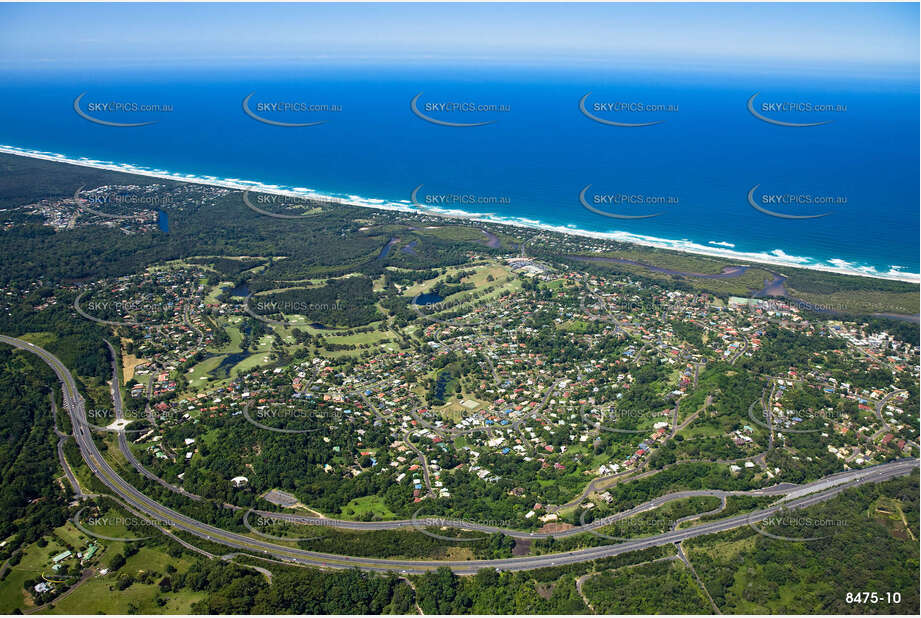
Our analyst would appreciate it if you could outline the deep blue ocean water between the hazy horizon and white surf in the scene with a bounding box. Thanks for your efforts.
[0,64,919,274]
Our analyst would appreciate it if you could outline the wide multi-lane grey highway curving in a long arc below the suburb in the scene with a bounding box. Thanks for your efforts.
[0,335,918,574]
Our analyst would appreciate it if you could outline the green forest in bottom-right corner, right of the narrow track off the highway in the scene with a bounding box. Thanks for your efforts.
[685,473,919,614]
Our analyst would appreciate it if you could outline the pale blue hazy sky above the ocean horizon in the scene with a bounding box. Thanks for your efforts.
[0,3,919,68]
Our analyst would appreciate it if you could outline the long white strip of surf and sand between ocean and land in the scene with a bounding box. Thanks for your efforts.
[0,145,921,284]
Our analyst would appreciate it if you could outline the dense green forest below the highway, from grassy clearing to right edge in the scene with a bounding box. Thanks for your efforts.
[113,475,919,614]
